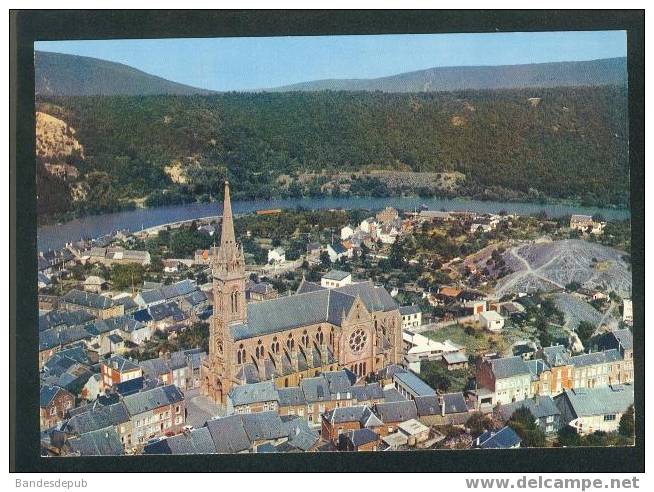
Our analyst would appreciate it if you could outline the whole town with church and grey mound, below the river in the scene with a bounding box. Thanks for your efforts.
[38,183,634,456]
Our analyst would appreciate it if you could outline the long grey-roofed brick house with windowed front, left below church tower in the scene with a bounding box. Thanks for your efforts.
[123,385,186,443]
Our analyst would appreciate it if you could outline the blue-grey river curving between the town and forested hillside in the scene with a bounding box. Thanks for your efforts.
[37,197,630,251]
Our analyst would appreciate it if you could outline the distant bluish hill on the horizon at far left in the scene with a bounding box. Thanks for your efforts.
[34,51,210,96]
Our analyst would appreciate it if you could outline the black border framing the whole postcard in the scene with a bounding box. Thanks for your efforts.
[9,10,645,473]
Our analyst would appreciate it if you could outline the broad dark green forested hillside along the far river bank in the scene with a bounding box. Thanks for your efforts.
[37,86,629,221]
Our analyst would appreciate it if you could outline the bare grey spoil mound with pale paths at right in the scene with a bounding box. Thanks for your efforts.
[496,239,631,297]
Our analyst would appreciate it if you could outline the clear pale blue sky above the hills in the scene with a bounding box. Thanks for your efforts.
[34,31,627,91]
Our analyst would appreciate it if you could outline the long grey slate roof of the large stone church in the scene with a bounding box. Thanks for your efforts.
[230,282,397,340]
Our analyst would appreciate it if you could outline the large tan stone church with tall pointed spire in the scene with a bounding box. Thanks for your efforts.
[201,182,402,403]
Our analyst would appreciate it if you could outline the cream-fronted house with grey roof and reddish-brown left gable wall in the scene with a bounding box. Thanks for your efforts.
[477,357,531,406]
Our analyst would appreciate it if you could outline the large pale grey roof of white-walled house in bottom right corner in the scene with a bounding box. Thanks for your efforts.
[557,385,634,417]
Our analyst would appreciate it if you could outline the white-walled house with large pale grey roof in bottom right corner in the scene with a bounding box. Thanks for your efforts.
[554,385,634,434]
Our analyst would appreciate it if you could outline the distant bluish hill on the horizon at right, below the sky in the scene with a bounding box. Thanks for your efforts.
[270,58,627,92]
